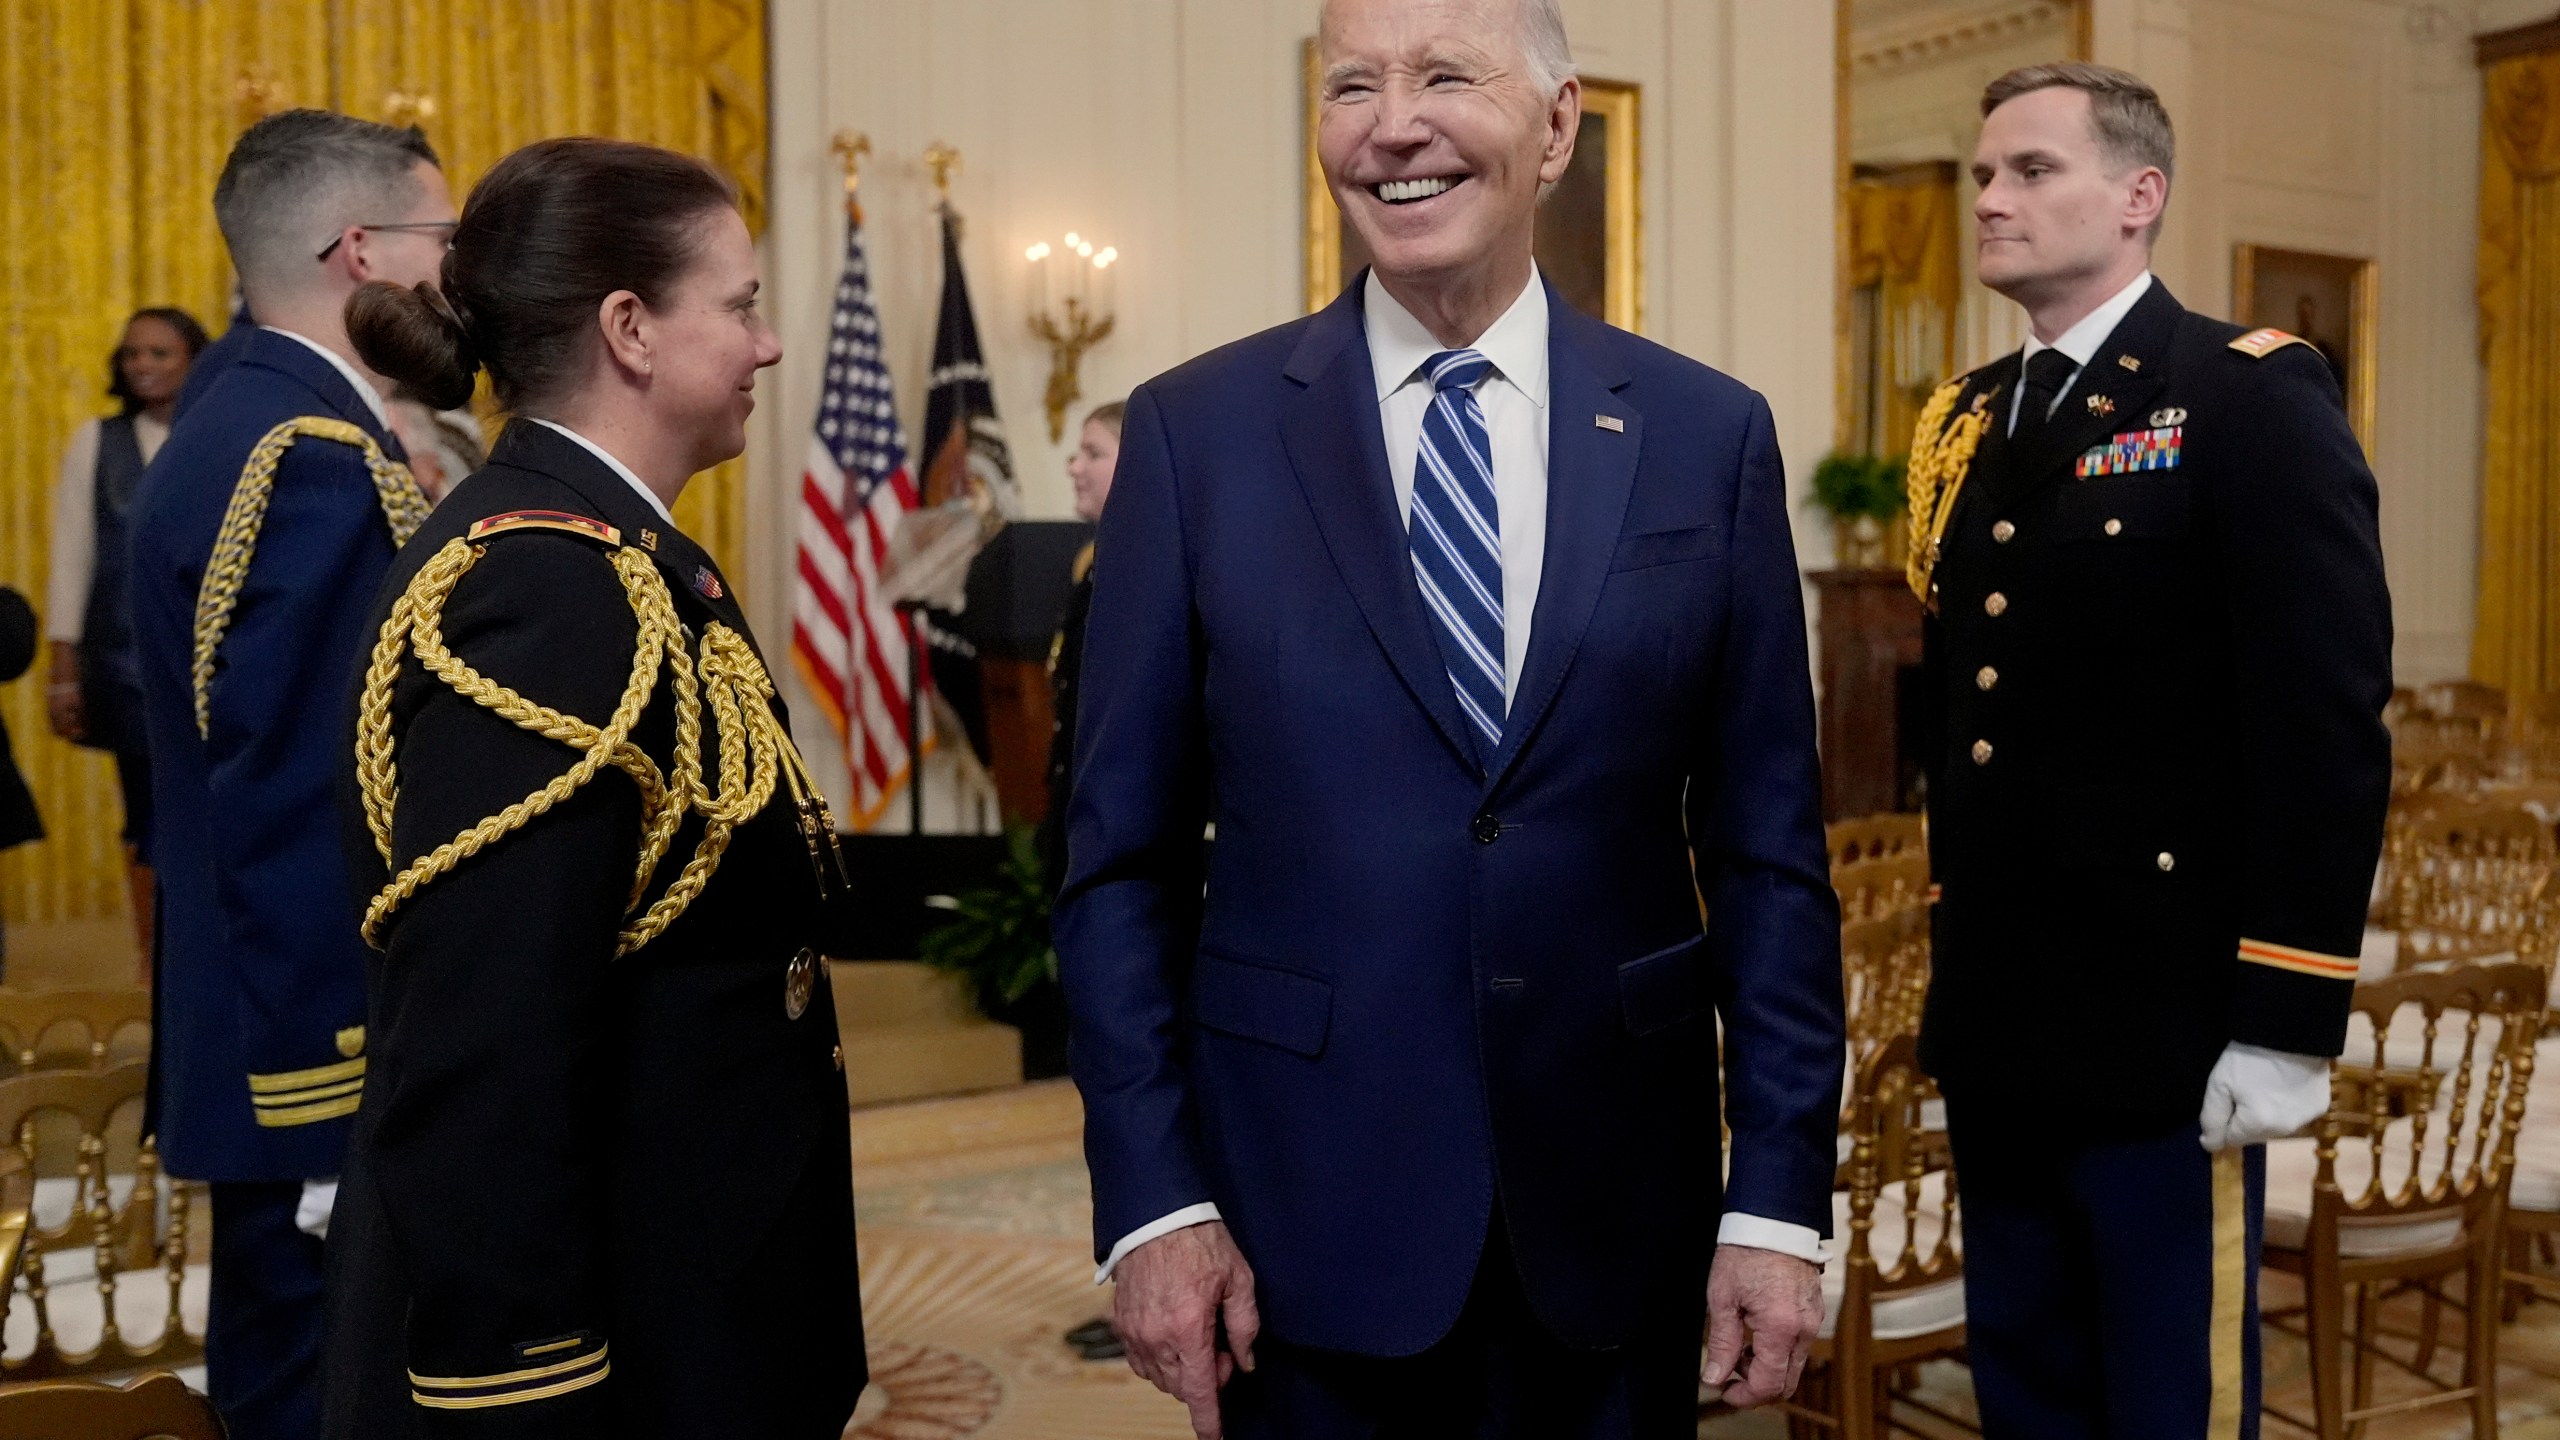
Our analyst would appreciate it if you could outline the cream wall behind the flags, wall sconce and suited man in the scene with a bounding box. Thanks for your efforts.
[748,0,1833,819]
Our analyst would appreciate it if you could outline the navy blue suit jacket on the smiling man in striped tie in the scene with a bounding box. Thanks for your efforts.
[1057,284,1843,1355]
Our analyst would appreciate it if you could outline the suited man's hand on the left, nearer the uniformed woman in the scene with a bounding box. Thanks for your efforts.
[1111,1220,1262,1440]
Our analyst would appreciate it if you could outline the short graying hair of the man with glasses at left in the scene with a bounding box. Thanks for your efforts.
[212,110,438,290]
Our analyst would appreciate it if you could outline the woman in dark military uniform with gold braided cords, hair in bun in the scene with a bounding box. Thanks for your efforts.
[325,138,865,1440]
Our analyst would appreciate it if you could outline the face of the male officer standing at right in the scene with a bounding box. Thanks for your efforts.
[1974,85,2168,310]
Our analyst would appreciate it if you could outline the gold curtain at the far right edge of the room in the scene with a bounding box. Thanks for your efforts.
[2470,51,2560,694]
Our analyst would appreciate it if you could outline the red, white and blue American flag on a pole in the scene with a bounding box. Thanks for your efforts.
[791,208,932,830]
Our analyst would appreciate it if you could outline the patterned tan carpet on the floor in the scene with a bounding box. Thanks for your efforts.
[847,1081,2560,1440]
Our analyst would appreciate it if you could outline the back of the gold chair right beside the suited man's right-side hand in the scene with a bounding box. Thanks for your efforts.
[1836,1035,1964,1343]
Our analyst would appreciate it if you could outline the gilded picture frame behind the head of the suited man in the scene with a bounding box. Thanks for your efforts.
[1300,41,1644,333]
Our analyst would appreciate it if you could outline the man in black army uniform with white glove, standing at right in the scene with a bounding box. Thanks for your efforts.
[1910,64,2391,1440]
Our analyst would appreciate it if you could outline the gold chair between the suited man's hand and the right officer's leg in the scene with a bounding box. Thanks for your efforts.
[1782,1035,1966,1440]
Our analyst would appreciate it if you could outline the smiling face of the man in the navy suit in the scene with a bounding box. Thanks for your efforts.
[1316,0,1582,299]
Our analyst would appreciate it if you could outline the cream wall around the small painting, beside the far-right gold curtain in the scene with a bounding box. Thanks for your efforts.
[2097,0,2508,682]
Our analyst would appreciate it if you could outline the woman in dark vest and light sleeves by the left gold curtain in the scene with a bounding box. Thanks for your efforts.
[44,305,205,958]
